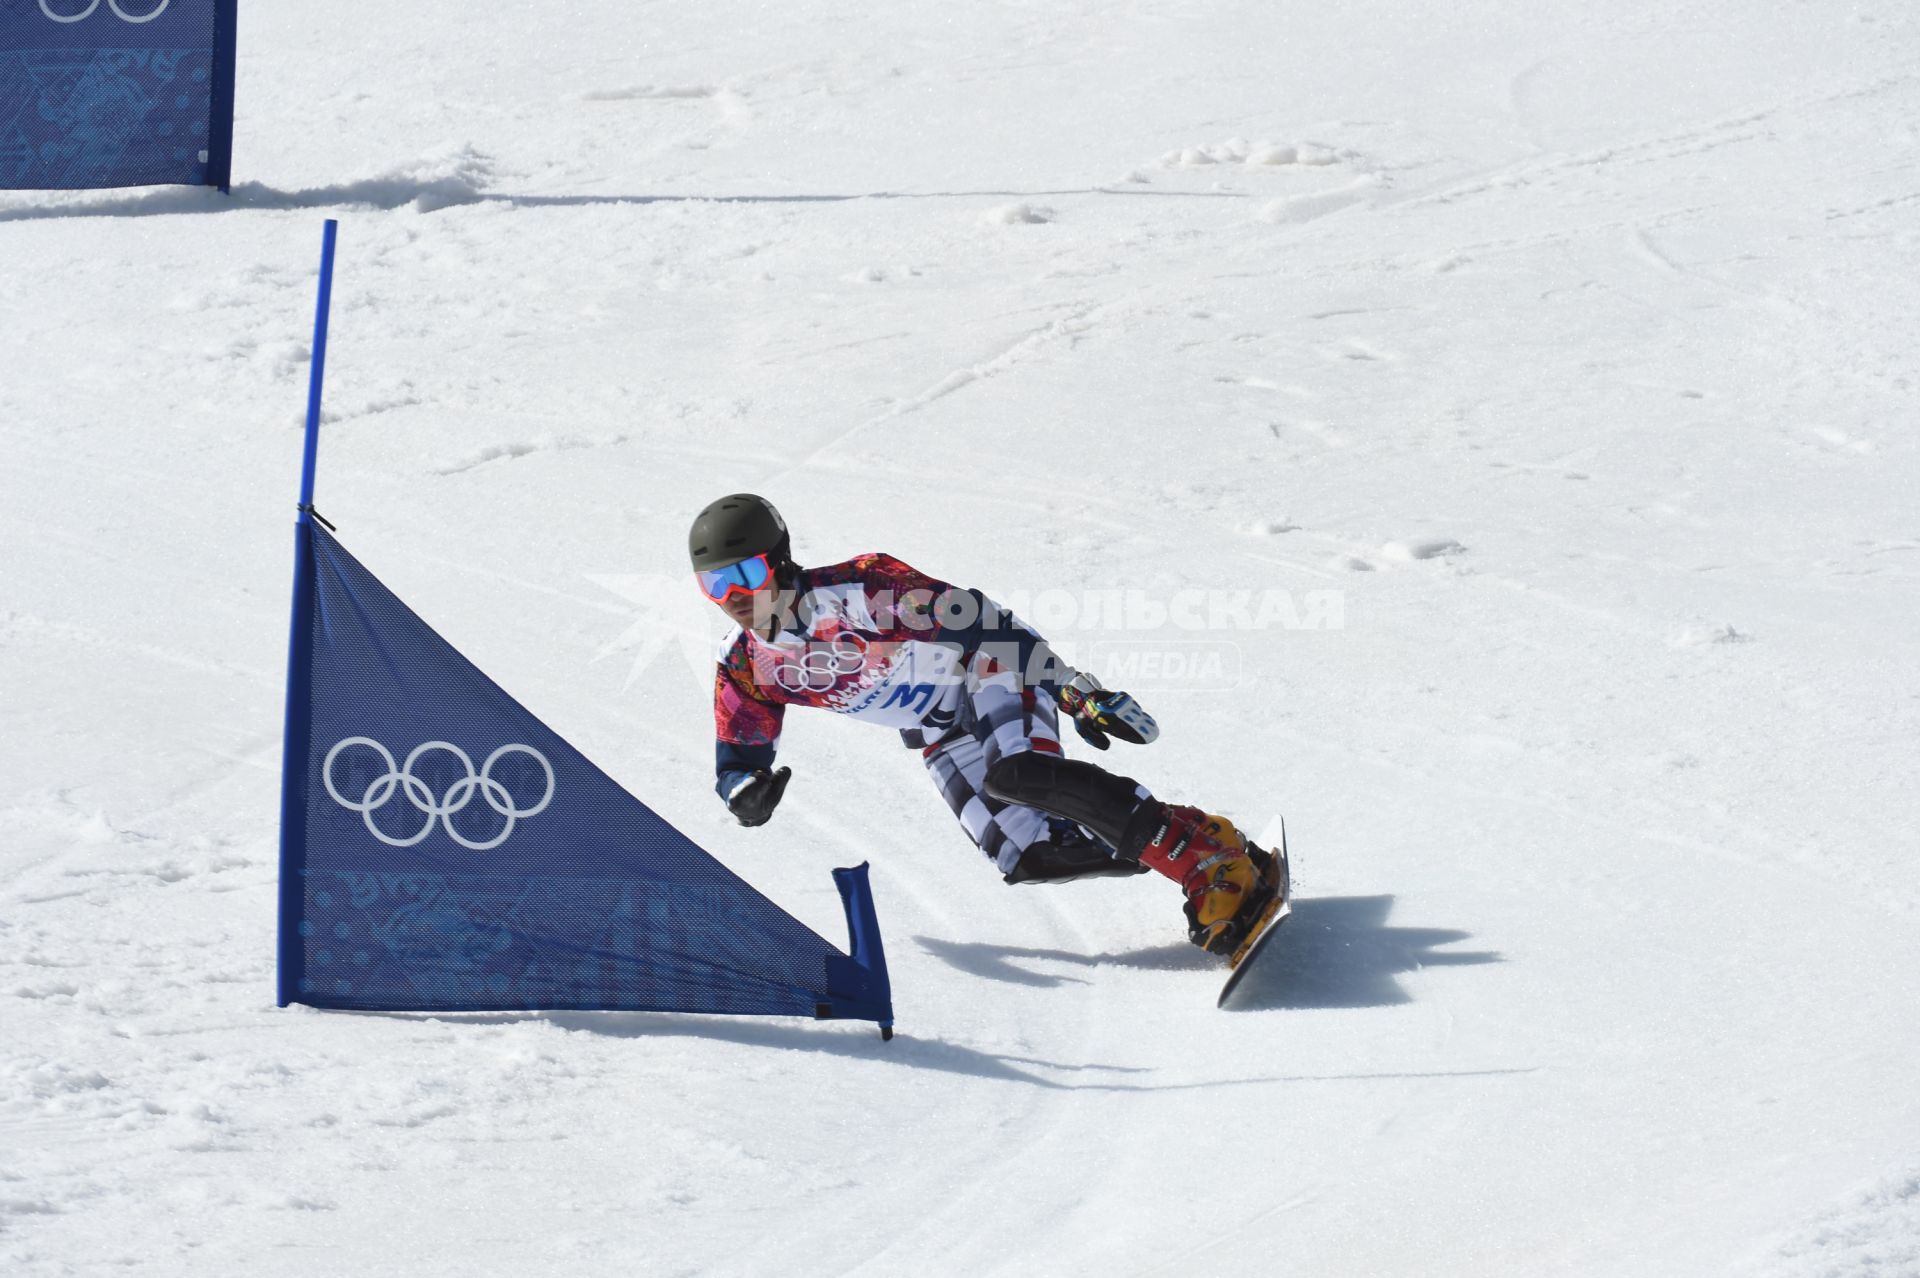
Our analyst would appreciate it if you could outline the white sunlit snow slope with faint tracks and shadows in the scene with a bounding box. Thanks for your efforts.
[0,0,1920,1278]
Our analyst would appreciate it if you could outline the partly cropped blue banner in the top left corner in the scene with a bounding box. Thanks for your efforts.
[0,0,238,190]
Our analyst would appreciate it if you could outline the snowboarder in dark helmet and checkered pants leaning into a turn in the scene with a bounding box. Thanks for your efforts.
[687,493,1281,956]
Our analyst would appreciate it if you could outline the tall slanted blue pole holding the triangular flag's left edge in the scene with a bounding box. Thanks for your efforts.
[275,219,340,1007]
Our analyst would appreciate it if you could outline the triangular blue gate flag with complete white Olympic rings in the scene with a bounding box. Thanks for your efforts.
[280,522,893,1023]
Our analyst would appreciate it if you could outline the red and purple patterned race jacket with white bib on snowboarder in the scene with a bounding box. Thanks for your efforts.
[714,555,1071,794]
